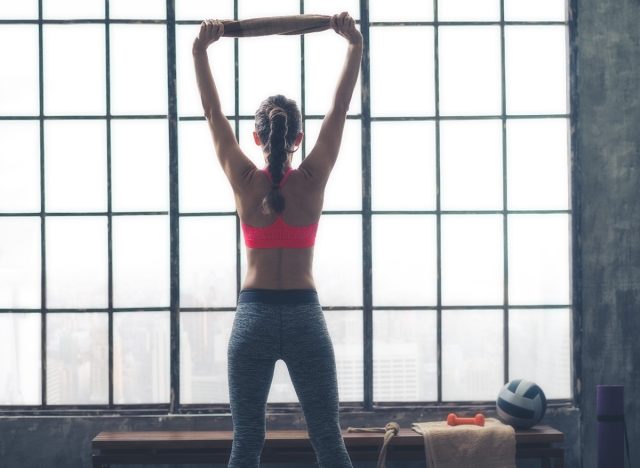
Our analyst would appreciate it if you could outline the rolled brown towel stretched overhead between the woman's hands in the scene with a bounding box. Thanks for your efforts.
[222,15,331,37]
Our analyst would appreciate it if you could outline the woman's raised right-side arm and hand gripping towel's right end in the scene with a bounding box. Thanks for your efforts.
[300,12,362,188]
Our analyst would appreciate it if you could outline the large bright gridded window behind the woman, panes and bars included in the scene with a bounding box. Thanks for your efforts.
[0,0,572,412]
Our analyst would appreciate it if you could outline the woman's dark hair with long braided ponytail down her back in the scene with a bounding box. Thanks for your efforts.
[256,94,302,214]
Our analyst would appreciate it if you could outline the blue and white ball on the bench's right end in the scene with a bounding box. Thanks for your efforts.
[496,379,547,428]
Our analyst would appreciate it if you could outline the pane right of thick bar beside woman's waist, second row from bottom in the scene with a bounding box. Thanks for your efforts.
[372,215,437,306]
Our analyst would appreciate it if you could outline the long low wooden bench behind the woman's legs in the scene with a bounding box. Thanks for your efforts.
[91,426,564,468]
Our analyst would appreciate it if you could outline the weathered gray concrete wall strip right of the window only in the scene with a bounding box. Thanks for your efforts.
[576,0,640,468]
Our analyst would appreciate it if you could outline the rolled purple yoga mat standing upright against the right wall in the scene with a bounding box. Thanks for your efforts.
[596,385,624,468]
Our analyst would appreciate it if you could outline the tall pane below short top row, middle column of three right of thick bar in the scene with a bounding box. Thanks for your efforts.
[439,26,502,115]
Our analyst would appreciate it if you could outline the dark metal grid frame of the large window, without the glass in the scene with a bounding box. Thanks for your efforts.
[0,0,581,416]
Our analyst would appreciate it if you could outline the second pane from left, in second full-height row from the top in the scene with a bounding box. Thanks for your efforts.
[44,120,107,212]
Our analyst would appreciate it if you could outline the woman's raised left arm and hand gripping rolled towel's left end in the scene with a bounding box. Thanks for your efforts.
[192,20,256,191]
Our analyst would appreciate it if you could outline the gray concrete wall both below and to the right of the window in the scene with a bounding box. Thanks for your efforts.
[0,0,640,468]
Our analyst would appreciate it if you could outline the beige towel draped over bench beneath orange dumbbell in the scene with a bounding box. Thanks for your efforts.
[411,418,516,468]
